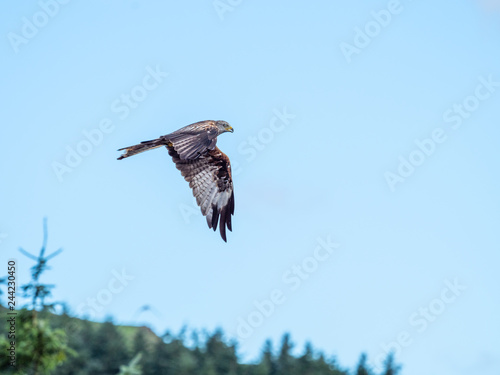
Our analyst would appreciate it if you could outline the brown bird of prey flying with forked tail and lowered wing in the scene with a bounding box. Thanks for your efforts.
[118,120,234,242]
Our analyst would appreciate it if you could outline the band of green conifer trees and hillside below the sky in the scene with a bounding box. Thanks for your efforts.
[0,222,401,375]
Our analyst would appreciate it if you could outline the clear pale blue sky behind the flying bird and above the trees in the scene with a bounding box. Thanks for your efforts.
[0,0,500,375]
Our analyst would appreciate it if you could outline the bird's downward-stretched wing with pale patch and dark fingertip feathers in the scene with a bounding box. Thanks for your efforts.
[167,142,234,241]
